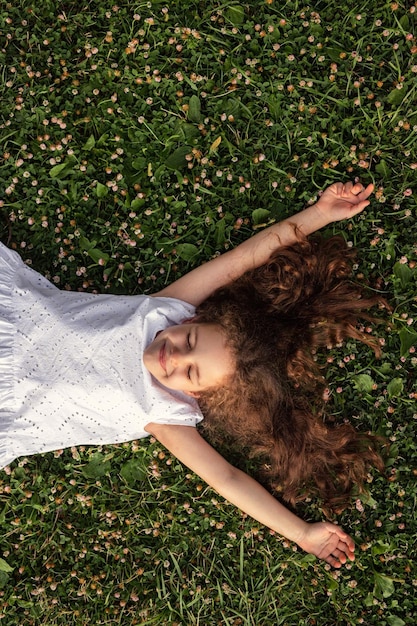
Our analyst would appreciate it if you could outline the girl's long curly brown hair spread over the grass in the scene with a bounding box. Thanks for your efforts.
[196,237,387,511]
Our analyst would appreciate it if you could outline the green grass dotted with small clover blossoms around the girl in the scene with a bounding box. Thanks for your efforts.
[0,0,417,626]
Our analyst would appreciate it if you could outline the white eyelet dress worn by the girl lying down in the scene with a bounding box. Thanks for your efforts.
[0,244,202,467]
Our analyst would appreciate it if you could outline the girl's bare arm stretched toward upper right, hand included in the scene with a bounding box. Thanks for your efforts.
[154,183,373,306]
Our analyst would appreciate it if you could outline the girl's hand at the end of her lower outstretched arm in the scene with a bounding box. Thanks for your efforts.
[297,522,355,567]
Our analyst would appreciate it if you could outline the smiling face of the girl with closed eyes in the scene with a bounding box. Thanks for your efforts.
[143,323,234,396]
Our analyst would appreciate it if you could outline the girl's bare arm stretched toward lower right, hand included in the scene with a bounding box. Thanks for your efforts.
[146,423,355,567]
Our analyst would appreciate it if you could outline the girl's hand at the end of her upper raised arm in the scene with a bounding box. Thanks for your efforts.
[315,183,374,223]
